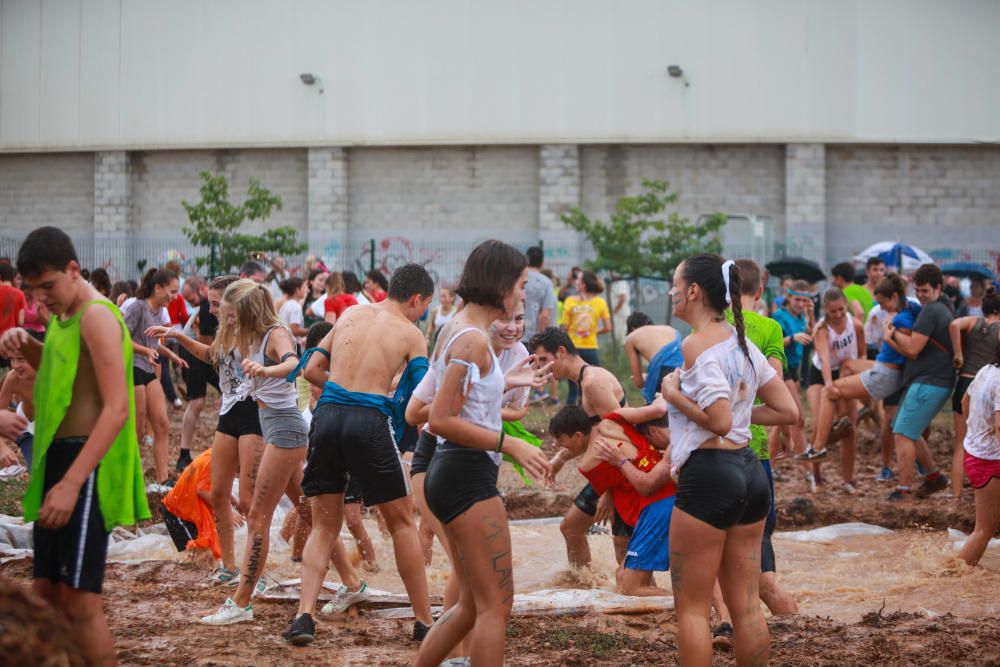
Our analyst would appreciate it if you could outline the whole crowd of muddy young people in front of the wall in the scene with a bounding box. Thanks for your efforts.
[0,227,1000,665]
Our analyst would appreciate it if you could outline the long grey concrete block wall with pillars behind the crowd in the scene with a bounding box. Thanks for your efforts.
[0,144,1000,280]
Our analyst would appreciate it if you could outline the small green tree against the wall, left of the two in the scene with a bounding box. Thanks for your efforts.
[182,171,306,275]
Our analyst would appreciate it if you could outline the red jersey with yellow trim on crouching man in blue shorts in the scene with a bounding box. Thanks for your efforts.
[580,413,677,526]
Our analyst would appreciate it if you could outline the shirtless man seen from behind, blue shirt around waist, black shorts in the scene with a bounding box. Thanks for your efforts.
[284,264,434,645]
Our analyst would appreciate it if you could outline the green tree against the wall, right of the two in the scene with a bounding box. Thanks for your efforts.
[562,179,726,280]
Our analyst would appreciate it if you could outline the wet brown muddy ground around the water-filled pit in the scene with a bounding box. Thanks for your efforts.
[0,394,1000,667]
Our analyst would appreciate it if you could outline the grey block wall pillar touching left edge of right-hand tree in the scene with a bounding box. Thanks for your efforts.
[538,144,585,274]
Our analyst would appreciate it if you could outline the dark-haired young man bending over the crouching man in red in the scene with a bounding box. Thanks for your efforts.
[528,327,632,567]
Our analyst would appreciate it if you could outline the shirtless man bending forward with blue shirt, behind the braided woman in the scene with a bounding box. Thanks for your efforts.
[625,312,684,405]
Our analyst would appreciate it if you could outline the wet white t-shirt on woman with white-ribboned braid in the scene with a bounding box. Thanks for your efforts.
[667,330,775,478]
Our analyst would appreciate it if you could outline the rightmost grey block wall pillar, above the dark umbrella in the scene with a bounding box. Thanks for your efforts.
[785,144,828,271]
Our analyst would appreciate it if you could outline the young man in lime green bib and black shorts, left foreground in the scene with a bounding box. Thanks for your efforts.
[0,227,150,665]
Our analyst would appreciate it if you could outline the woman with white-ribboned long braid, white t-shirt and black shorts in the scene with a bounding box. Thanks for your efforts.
[662,254,798,665]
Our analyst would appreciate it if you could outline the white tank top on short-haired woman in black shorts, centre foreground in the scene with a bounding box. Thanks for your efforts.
[434,327,504,465]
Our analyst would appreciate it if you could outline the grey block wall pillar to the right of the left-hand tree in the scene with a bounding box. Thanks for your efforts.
[306,147,350,266]
